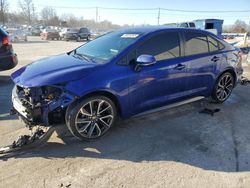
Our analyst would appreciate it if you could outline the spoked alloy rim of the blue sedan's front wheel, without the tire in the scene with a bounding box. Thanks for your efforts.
[75,99,114,139]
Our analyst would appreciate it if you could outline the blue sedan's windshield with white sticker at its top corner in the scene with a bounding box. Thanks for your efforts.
[72,32,140,63]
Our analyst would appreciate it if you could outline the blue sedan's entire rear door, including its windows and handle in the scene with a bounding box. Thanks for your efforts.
[183,31,219,95]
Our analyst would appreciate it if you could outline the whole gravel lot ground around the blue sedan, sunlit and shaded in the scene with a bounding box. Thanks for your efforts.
[0,37,250,188]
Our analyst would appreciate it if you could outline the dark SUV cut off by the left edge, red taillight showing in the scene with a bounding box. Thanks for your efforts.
[0,28,18,71]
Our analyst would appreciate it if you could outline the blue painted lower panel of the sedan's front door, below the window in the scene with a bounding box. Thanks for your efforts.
[129,58,187,113]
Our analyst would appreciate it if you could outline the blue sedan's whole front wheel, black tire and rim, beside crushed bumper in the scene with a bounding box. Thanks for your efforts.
[65,96,117,141]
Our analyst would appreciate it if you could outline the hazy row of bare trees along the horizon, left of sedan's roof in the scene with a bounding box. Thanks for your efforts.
[0,0,121,30]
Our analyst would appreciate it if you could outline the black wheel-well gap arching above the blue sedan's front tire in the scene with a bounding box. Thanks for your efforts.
[75,91,121,115]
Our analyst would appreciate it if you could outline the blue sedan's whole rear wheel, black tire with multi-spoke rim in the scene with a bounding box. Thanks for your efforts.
[211,72,235,103]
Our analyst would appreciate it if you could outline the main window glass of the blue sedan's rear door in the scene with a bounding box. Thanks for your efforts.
[184,31,209,56]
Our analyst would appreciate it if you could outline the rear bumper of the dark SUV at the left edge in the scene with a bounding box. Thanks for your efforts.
[0,54,18,71]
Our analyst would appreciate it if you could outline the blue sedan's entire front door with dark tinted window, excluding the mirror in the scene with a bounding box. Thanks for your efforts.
[129,31,187,114]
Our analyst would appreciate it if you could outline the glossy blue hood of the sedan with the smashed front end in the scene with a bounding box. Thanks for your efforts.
[11,54,98,87]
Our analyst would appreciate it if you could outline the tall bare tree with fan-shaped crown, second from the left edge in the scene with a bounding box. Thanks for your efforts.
[19,0,36,25]
